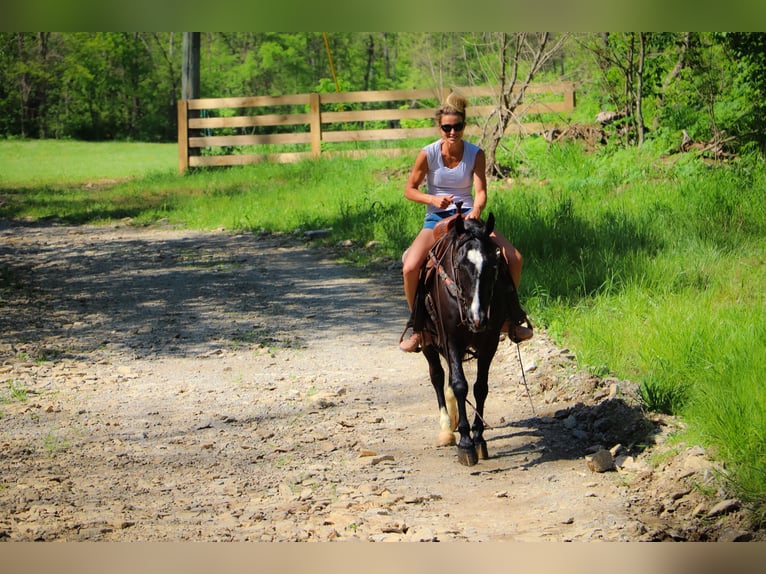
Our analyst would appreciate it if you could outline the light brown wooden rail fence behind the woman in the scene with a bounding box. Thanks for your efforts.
[178,82,575,173]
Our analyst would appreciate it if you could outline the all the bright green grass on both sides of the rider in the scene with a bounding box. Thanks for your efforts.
[0,139,766,512]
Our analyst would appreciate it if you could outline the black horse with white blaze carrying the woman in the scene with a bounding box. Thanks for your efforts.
[413,214,518,466]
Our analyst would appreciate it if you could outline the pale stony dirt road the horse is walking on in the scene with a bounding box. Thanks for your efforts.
[0,223,757,541]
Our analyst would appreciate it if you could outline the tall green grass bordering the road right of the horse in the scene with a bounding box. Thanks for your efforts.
[506,145,766,508]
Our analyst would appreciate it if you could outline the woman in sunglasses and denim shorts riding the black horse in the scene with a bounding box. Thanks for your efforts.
[399,92,532,352]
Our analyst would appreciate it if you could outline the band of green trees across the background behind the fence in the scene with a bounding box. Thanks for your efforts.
[0,32,766,153]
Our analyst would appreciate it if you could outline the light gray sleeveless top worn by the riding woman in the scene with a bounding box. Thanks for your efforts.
[423,140,481,213]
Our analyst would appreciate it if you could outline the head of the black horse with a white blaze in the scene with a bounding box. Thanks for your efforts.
[454,213,498,333]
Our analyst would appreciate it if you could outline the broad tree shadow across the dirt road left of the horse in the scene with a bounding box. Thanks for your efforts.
[0,222,406,358]
